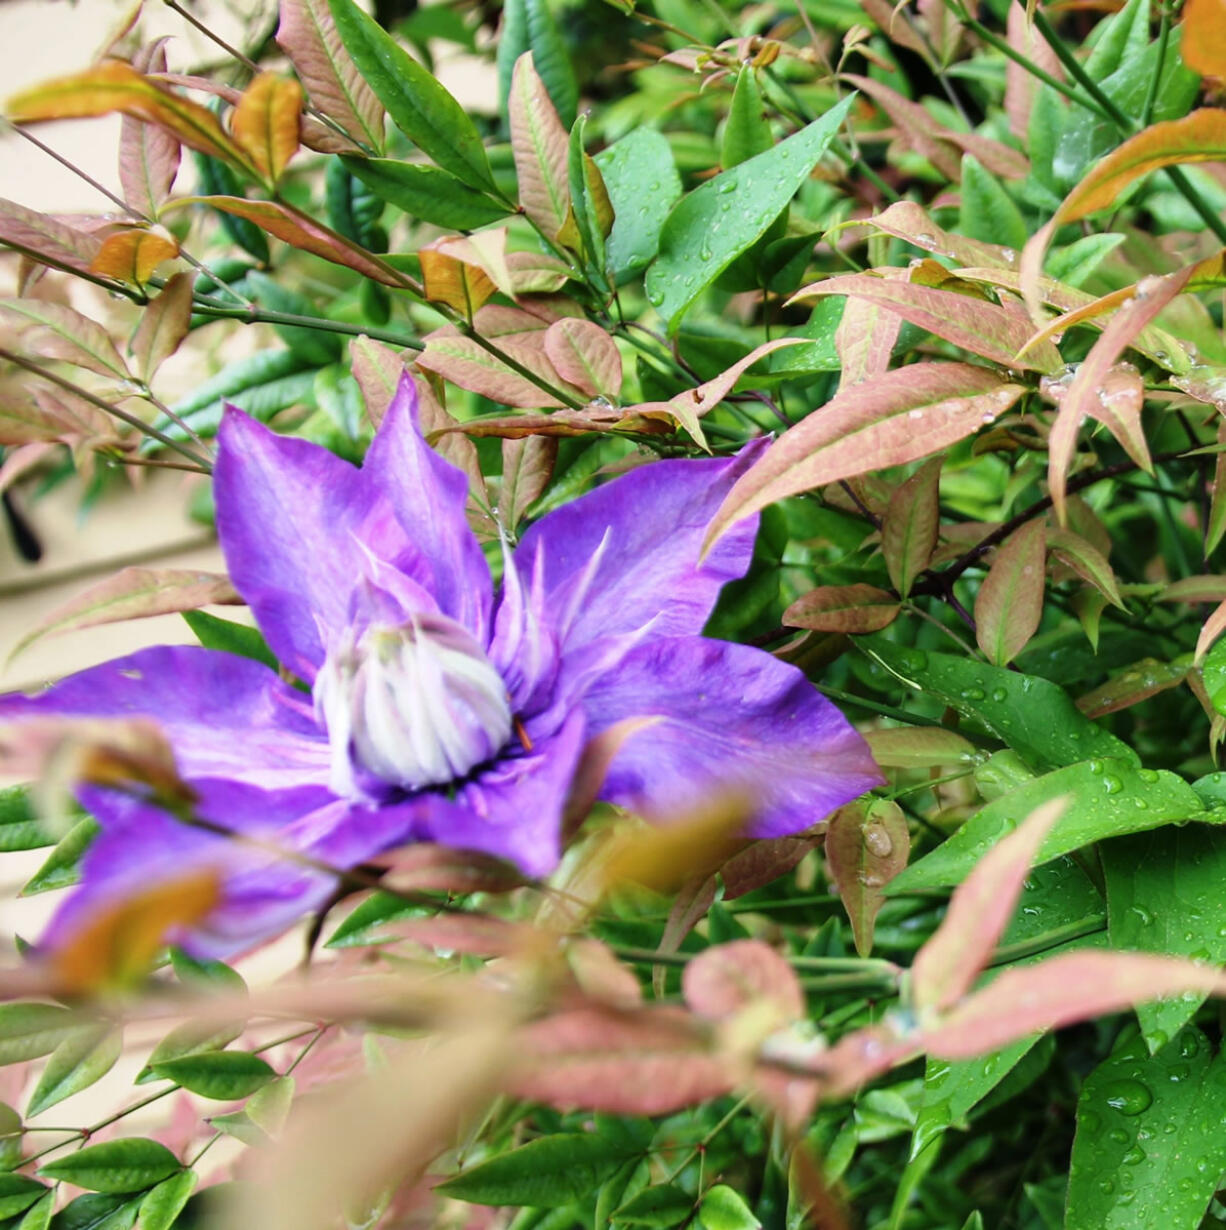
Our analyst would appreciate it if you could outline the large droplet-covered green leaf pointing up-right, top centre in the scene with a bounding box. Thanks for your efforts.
[649,96,855,332]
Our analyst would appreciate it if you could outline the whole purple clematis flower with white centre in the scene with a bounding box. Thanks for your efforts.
[0,376,880,956]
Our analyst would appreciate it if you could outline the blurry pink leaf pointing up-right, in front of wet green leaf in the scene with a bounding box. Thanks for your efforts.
[911,798,1069,1014]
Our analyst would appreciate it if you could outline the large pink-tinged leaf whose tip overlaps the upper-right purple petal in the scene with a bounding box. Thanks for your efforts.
[706,363,1024,547]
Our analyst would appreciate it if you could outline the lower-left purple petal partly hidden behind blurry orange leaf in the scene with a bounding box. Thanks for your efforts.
[42,781,417,957]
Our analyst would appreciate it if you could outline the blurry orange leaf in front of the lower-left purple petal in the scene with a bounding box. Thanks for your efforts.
[50,871,221,993]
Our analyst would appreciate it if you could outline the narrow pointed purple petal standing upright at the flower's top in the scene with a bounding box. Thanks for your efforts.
[361,373,493,641]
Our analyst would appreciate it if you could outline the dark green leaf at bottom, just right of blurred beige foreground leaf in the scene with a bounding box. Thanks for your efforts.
[435,1132,628,1209]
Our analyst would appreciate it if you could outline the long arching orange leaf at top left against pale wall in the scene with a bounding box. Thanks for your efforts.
[7,60,253,171]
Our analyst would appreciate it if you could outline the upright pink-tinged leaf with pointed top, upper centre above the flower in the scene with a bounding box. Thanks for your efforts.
[508,52,571,239]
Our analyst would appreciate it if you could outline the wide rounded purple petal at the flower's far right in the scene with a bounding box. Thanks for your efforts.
[584,637,883,836]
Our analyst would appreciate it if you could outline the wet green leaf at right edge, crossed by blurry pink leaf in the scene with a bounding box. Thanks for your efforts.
[1102,824,1226,1052]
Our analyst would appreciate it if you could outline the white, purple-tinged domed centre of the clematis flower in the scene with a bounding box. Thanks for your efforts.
[314,615,512,796]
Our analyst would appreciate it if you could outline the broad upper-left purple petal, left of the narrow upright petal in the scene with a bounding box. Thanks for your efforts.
[214,408,429,683]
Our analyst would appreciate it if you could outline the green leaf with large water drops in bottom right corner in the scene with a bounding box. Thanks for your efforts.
[1064,1027,1226,1230]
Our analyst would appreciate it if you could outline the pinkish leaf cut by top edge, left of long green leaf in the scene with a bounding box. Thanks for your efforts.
[277,0,384,151]
